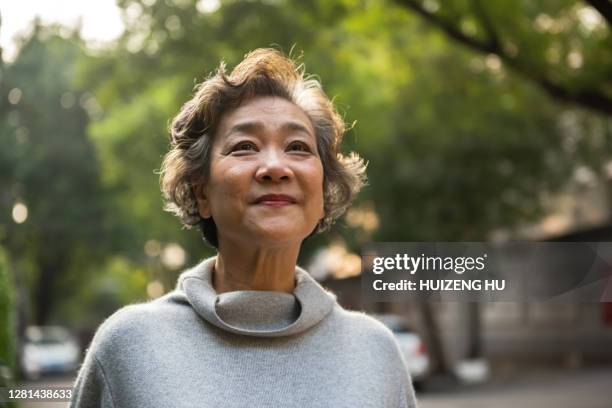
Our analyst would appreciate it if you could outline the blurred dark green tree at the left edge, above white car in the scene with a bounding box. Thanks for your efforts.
[0,23,111,324]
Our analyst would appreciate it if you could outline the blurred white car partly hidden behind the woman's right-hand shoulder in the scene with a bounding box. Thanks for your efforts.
[373,314,430,387]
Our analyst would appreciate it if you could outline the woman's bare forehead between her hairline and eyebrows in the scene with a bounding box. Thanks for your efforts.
[218,96,315,136]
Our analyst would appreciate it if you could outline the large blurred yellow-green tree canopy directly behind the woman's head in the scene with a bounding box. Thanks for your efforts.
[32,0,612,372]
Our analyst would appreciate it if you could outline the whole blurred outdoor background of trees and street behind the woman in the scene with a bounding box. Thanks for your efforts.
[0,0,612,408]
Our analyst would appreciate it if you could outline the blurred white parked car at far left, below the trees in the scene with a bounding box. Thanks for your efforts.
[21,326,81,379]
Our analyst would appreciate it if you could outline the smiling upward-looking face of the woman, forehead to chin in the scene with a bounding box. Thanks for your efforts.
[196,96,324,246]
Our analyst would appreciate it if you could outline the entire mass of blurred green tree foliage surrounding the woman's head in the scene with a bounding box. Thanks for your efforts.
[0,0,612,328]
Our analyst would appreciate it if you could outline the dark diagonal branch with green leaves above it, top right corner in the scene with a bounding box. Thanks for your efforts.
[397,0,612,115]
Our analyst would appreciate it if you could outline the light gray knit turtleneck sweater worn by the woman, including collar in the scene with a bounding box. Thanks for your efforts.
[70,258,416,408]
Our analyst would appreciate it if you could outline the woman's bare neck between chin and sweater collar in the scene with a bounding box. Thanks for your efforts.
[213,242,300,293]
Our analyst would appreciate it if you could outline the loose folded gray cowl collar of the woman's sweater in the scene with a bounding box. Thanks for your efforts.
[177,257,336,337]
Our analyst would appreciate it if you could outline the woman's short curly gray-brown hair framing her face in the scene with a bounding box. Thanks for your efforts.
[160,48,366,247]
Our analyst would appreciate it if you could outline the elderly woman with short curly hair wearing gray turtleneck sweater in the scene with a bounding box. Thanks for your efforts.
[71,49,416,408]
